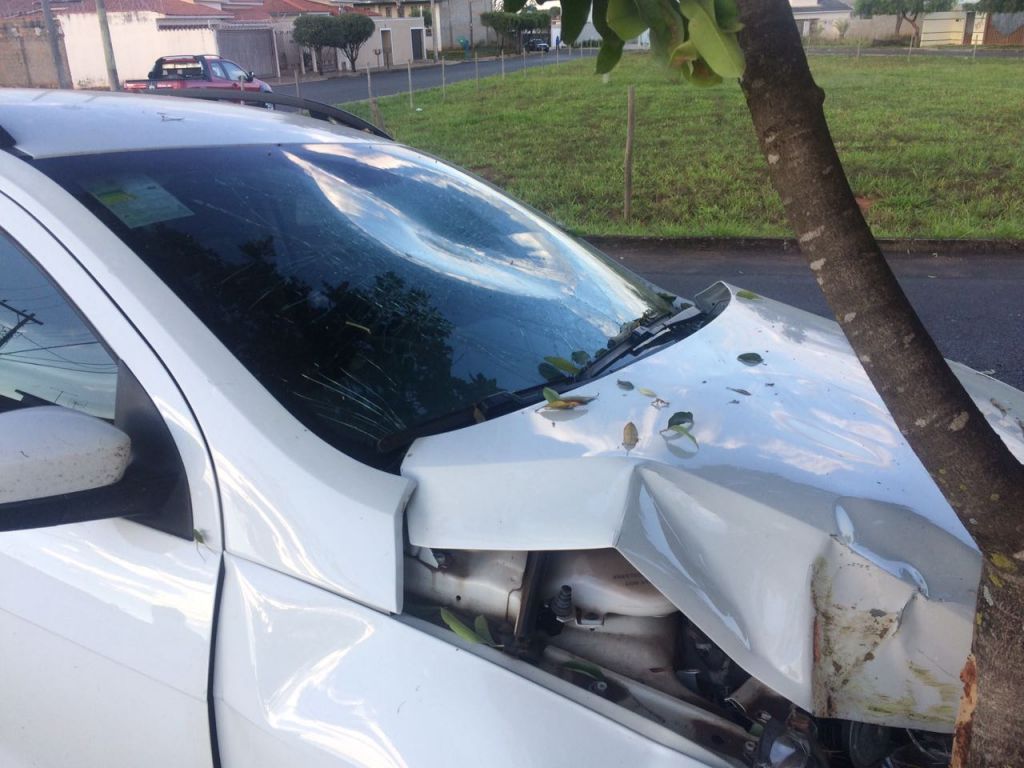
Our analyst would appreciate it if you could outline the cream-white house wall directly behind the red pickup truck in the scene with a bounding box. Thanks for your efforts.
[59,11,217,88]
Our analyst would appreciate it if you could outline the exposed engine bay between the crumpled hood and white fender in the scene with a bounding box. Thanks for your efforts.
[404,547,950,768]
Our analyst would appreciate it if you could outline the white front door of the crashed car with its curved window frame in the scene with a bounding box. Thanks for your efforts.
[0,195,220,768]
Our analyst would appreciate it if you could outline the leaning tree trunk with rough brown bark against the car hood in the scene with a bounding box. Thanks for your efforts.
[738,0,1024,768]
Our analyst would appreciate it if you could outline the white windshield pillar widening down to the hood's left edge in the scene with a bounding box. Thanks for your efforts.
[0,150,412,611]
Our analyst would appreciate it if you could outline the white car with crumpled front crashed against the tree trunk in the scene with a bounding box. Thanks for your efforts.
[0,91,1024,768]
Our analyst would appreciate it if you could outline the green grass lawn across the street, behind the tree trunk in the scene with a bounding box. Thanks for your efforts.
[347,55,1024,240]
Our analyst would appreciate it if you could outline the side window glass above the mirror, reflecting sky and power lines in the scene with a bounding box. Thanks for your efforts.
[0,230,118,421]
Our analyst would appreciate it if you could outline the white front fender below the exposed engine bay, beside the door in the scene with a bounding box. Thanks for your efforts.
[214,555,729,768]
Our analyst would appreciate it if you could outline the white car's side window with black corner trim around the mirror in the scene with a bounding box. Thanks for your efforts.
[0,230,193,539]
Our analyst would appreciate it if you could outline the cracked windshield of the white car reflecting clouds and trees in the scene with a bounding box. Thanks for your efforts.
[37,142,670,465]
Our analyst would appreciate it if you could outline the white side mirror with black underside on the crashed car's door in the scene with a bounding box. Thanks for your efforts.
[0,406,140,530]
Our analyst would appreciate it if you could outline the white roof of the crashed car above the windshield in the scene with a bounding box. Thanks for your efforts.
[0,89,380,158]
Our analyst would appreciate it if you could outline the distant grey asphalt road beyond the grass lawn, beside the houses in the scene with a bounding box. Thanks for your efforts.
[273,48,596,104]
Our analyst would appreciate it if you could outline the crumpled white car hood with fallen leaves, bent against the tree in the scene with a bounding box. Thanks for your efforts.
[402,284,1024,731]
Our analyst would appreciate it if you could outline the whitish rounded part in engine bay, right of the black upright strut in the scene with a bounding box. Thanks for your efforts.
[541,549,676,620]
